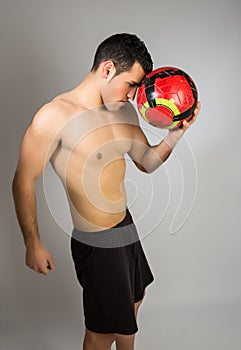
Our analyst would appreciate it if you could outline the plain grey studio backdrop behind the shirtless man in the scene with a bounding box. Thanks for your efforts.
[0,0,241,350]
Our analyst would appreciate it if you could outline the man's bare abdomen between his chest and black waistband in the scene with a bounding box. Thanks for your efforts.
[66,158,126,231]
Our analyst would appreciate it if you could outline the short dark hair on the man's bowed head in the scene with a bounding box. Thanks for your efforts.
[91,33,153,75]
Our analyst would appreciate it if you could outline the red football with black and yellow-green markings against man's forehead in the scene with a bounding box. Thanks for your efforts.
[137,67,198,129]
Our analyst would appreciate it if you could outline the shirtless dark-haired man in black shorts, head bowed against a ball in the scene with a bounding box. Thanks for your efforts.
[13,34,200,350]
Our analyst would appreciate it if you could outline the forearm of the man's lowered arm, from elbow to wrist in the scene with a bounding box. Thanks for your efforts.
[12,175,40,248]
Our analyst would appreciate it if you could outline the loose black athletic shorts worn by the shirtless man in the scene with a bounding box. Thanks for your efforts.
[71,210,154,334]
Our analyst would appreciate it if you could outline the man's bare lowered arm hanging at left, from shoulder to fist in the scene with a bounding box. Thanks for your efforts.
[12,102,62,274]
